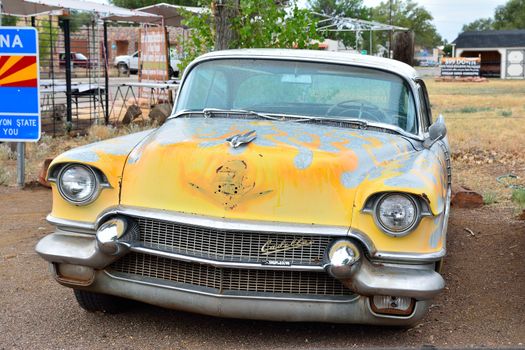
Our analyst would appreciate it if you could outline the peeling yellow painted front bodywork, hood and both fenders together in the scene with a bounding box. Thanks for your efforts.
[47,119,447,253]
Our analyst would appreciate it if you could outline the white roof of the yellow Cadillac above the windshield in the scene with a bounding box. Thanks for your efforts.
[196,49,418,79]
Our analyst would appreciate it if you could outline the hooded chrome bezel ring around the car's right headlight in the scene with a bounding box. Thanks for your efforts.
[363,192,431,237]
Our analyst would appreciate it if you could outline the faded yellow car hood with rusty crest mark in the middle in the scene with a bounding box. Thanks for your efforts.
[121,118,424,227]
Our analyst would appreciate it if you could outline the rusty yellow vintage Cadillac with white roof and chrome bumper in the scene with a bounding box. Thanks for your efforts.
[36,49,450,326]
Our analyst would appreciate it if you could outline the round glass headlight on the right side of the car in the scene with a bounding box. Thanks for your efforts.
[375,193,419,236]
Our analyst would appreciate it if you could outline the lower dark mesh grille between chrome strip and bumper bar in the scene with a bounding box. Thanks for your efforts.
[110,253,353,296]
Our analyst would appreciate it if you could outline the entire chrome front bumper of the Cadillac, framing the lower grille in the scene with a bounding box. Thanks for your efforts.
[36,224,444,325]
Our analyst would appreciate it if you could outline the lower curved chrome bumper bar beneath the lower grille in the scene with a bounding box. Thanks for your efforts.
[79,271,430,326]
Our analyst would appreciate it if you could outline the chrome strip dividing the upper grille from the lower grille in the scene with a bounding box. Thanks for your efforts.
[130,246,325,272]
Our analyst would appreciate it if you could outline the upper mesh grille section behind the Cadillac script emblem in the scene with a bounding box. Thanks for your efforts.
[136,218,332,265]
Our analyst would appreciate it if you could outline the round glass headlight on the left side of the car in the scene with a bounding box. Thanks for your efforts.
[58,164,99,204]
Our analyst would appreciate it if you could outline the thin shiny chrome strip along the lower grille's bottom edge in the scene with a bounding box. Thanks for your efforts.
[104,270,361,303]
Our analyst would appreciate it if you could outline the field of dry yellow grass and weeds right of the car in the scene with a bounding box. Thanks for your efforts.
[426,80,525,212]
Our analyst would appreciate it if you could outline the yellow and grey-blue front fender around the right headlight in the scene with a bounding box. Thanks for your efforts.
[352,149,448,256]
